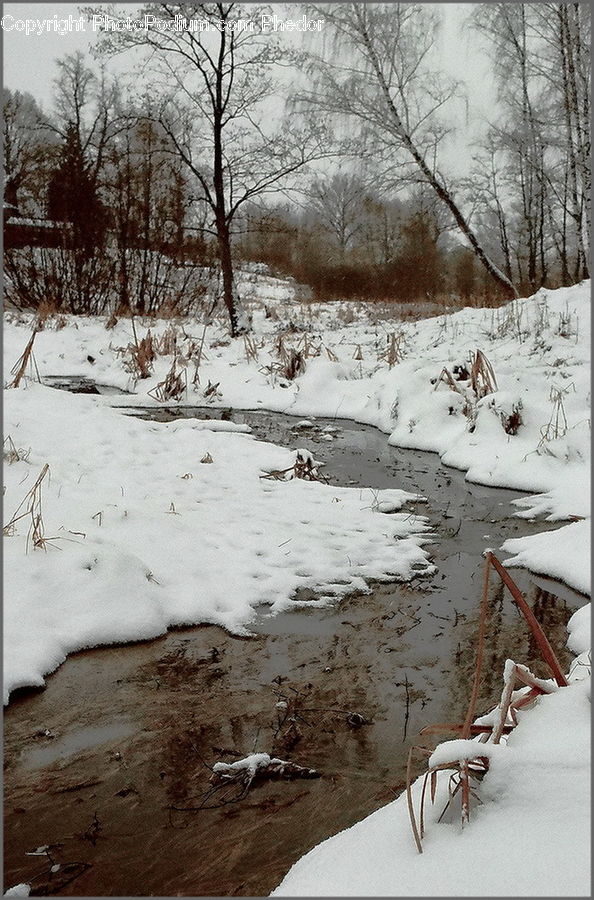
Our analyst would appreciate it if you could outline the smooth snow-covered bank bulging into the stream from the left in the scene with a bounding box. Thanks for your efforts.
[4,383,431,700]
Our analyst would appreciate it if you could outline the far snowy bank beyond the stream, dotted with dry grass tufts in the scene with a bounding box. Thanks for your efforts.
[5,279,590,594]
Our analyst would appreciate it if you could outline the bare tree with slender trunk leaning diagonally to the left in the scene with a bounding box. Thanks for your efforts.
[305,3,517,296]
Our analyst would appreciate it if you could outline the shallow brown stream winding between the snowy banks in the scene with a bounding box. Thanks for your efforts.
[4,410,585,897]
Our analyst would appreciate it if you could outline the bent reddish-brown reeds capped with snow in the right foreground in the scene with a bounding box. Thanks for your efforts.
[406,552,568,853]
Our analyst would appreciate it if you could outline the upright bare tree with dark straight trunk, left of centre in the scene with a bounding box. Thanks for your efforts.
[88,3,326,336]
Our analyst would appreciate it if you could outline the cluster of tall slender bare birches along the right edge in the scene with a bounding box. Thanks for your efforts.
[473,3,591,287]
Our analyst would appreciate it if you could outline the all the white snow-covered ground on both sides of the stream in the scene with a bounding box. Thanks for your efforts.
[4,278,590,896]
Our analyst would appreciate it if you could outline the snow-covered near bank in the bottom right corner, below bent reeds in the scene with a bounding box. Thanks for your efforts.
[272,606,590,897]
